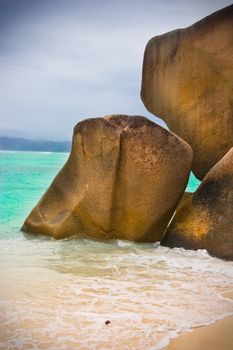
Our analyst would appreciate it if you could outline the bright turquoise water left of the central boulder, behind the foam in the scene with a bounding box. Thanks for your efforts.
[0,152,68,235]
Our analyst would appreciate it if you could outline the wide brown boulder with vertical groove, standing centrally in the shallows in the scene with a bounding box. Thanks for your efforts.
[22,115,192,242]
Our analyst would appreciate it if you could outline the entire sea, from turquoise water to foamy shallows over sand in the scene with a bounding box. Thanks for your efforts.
[0,151,233,350]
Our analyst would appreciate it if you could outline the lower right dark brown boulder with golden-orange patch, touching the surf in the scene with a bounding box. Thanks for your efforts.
[161,148,233,260]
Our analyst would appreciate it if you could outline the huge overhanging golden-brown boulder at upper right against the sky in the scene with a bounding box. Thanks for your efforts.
[141,5,233,179]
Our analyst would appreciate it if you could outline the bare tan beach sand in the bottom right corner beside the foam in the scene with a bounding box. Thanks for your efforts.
[163,290,233,350]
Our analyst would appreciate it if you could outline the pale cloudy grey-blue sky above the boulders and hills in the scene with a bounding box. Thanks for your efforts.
[0,0,232,140]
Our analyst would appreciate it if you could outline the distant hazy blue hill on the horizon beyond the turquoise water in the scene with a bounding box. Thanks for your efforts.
[0,136,71,152]
